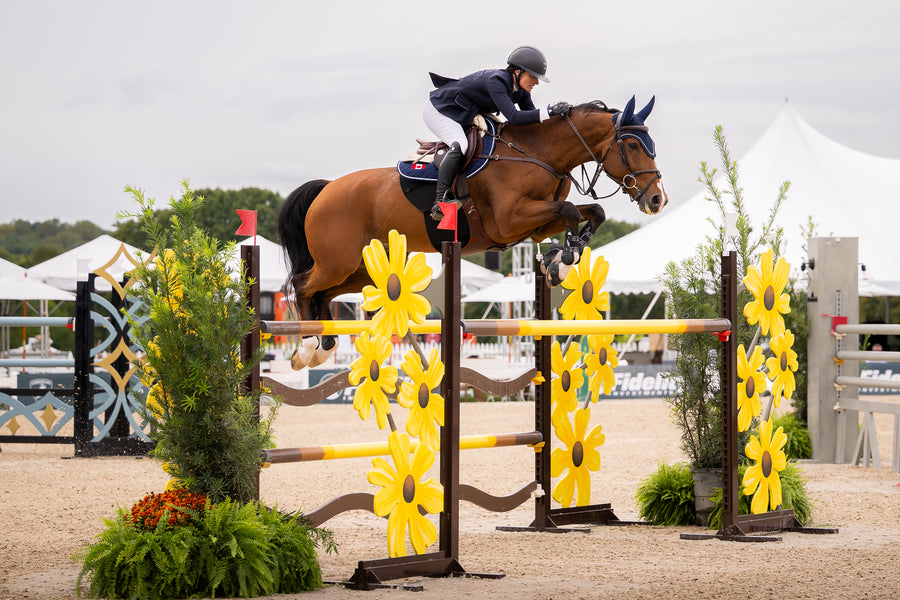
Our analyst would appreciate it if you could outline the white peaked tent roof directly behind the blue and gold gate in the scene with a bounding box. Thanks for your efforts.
[27,234,138,291]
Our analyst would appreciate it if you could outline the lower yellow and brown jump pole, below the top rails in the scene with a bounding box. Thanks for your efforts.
[265,431,544,464]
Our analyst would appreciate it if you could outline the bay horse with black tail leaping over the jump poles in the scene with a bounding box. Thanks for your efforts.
[278,97,668,369]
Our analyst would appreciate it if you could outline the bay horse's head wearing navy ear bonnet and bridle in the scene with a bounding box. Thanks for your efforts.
[601,96,669,215]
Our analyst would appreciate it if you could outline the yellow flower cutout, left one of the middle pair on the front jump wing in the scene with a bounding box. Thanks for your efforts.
[349,332,397,429]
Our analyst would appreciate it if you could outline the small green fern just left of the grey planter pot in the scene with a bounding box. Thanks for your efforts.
[634,461,697,525]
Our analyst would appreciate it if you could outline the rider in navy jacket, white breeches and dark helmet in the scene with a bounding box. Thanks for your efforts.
[422,46,572,221]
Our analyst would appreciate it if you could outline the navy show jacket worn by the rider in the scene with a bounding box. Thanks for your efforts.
[429,69,541,127]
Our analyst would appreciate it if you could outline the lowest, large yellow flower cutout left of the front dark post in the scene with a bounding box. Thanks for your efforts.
[367,431,444,558]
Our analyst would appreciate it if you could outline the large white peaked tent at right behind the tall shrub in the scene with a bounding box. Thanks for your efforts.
[592,104,900,295]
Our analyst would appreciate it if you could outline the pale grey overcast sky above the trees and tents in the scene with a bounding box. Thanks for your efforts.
[0,0,900,227]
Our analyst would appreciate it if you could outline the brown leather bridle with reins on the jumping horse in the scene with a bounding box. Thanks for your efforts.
[479,108,662,209]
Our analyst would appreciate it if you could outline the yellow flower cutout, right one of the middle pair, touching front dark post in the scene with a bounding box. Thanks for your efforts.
[397,348,444,452]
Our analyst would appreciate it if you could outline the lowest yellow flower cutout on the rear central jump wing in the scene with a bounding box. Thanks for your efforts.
[550,408,606,508]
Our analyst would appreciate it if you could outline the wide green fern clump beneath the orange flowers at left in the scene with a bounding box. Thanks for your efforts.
[75,500,335,599]
